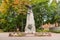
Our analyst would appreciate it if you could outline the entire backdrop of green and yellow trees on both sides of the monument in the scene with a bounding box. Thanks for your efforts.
[0,0,60,31]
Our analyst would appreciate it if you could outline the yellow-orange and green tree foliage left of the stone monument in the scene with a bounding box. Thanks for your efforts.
[0,0,27,31]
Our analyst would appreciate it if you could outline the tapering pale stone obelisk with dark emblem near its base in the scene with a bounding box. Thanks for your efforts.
[25,6,36,33]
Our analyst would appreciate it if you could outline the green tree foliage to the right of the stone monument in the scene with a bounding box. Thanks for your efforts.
[33,1,60,28]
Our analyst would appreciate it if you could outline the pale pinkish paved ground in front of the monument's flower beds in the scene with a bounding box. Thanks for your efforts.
[0,33,60,40]
